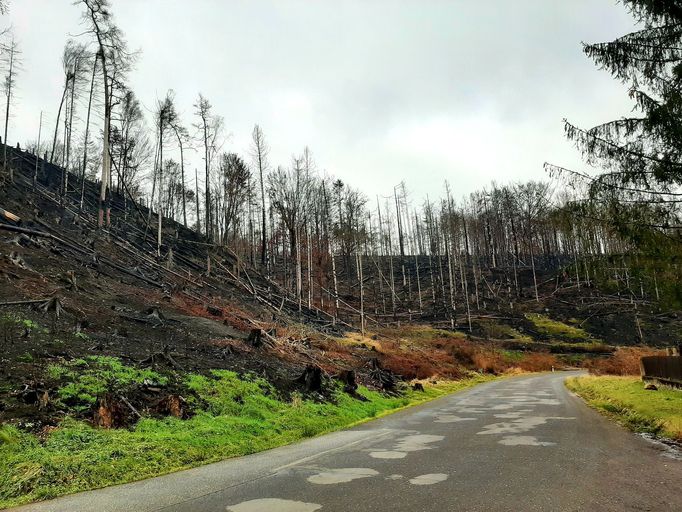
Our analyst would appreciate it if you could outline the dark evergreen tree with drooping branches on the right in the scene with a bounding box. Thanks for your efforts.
[546,0,682,243]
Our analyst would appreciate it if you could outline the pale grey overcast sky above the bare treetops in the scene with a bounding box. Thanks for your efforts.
[2,0,633,200]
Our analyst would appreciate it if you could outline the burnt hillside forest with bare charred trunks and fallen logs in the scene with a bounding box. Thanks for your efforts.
[0,0,682,428]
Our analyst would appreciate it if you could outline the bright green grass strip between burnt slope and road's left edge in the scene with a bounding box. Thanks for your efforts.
[0,365,491,508]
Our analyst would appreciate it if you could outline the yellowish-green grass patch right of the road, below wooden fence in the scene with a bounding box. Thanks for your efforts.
[566,376,682,441]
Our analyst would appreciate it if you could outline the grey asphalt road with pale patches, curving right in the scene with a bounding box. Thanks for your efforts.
[13,373,682,512]
